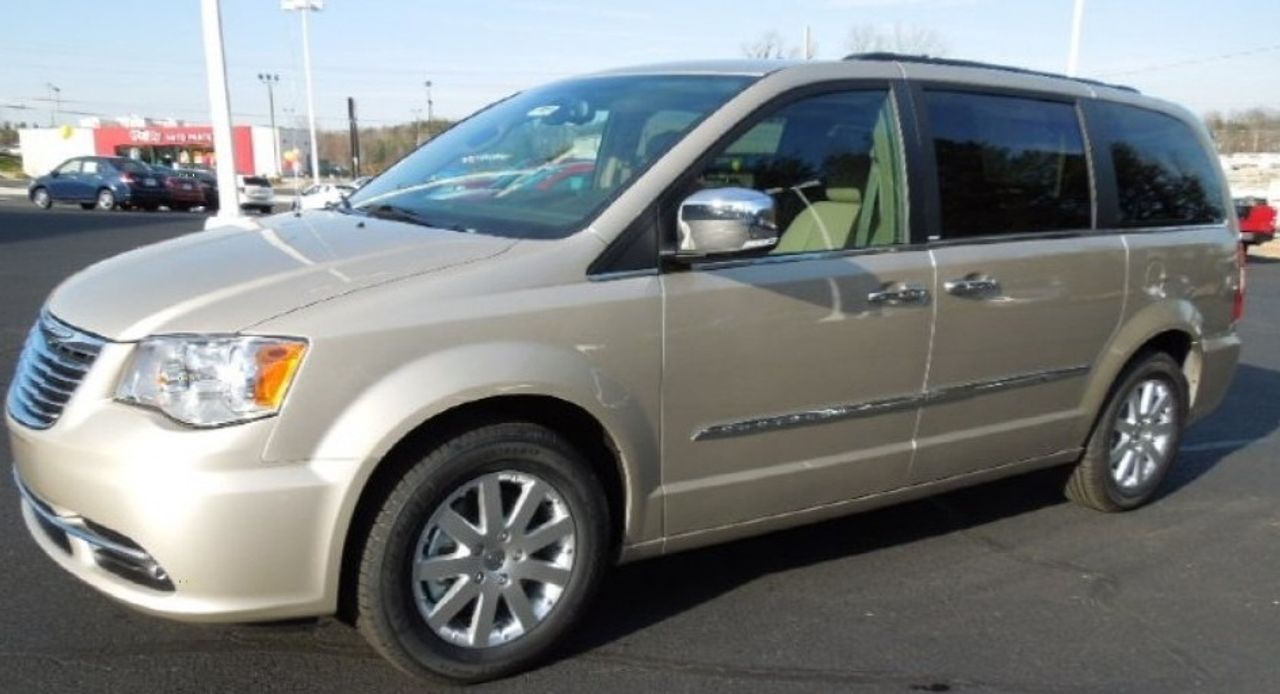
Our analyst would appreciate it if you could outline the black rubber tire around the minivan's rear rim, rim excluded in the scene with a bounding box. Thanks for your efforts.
[1066,352,1189,512]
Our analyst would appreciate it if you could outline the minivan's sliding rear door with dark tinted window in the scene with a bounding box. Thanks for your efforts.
[911,90,1126,483]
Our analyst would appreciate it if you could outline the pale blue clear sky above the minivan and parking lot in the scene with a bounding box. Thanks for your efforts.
[0,0,1280,129]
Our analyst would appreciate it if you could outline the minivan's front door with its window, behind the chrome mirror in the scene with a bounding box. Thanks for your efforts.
[662,87,934,535]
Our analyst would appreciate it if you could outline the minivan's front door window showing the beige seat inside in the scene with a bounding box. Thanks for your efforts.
[698,90,902,255]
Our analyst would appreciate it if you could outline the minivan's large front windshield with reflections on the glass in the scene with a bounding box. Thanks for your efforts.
[351,76,754,238]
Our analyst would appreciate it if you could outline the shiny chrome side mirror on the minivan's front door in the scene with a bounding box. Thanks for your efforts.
[676,188,778,259]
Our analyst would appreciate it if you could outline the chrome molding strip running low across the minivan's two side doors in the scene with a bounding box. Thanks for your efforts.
[692,364,1091,440]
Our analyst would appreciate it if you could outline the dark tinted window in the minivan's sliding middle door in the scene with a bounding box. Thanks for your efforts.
[924,91,1092,238]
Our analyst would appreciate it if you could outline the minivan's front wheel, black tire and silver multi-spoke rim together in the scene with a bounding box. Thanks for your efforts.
[357,424,608,682]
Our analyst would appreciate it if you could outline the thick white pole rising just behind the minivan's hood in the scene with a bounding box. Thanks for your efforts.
[200,0,241,228]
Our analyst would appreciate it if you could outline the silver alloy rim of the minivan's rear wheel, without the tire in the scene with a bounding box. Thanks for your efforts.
[1111,378,1176,492]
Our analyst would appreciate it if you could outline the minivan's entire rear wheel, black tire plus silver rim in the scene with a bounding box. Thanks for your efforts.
[1066,352,1188,511]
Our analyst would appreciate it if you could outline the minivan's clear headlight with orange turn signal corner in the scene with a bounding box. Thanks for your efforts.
[115,335,307,426]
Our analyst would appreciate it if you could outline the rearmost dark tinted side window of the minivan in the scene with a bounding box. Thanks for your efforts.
[1089,102,1224,227]
